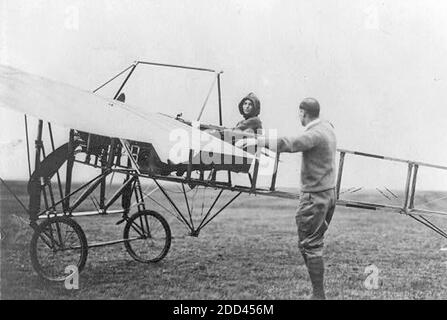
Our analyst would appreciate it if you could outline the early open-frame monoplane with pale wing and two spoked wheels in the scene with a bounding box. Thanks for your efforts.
[0,61,447,281]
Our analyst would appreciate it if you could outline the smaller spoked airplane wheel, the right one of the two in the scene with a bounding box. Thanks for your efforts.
[124,210,171,263]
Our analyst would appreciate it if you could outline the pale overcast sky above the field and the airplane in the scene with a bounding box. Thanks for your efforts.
[0,0,447,190]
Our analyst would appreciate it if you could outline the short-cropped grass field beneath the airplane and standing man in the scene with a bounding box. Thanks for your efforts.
[0,182,447,299]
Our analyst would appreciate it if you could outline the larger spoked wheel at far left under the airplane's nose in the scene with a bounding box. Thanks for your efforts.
[30,217,88,281]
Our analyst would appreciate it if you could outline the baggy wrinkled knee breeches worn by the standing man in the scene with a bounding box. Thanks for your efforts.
[295,189,336,258]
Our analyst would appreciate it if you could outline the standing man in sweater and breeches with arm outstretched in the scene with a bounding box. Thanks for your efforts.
[238,98,336,299]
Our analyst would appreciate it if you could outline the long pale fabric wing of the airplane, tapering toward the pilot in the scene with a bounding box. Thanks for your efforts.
[0,65,254,164]
